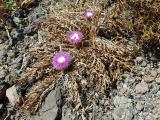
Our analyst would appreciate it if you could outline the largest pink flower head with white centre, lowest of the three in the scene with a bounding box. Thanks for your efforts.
[52,51,72,70]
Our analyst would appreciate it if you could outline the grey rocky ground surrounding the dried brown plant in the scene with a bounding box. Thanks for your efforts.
[0,1,160,120]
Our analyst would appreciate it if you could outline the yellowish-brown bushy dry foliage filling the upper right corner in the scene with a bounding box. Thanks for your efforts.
[102,0,160,60]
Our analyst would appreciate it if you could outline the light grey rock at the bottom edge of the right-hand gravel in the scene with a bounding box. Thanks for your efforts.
[112,106,133,120]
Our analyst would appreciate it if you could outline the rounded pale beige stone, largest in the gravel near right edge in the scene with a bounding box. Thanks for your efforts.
[135,82,149,94]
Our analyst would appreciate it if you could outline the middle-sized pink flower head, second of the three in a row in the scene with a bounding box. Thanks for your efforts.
[67,31,83,45]
